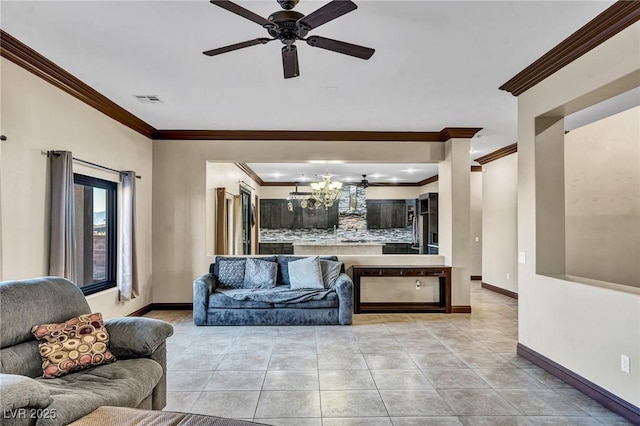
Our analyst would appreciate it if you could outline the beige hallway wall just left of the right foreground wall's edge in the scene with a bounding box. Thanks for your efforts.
[482,154,518,293]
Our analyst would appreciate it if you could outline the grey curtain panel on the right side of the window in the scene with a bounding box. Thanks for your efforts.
[118,171,140,301]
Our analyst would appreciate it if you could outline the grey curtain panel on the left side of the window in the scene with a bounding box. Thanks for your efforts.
[49,151,78,282]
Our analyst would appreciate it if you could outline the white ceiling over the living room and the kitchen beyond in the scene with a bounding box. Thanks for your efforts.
[0,0,613,185]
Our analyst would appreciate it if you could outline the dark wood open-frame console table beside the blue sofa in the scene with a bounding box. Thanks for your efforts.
[352,265,451,314]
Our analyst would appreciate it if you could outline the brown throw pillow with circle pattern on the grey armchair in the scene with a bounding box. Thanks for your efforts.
[31,313,116,379]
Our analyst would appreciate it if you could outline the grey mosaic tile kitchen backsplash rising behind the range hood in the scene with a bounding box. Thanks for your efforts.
[260,185,412,243]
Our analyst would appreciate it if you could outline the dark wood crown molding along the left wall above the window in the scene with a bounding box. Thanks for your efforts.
[0,30,156,138]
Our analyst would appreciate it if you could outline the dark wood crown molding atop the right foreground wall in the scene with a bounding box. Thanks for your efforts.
[500,0,640,96]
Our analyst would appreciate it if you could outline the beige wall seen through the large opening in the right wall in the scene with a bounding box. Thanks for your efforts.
[565,107,640,287]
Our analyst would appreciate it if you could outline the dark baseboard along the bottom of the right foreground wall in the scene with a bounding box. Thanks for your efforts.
[517,343,640,424]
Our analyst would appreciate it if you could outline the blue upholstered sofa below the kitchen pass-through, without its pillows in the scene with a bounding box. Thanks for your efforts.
[193,255,353,325]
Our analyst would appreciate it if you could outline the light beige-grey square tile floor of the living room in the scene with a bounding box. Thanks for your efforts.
[147,281,630,426]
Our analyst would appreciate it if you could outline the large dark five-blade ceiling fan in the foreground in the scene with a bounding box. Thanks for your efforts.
[202,0,375,78]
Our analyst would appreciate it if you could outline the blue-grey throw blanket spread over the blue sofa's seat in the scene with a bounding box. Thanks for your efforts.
[216,287,335,303]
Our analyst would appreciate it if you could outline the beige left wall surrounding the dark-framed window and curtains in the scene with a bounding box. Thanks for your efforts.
[0,58,153,317]
